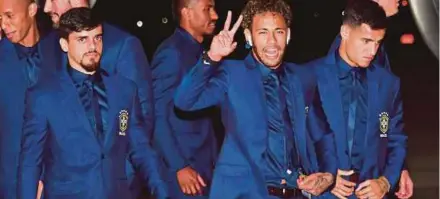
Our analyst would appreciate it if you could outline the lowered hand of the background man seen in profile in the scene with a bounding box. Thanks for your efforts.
[177,166,206,195]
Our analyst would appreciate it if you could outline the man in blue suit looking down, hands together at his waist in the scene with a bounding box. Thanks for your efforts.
[306,0,407,198]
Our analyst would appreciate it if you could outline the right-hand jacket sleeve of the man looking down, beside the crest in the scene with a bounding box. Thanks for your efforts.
[383,78,408,189]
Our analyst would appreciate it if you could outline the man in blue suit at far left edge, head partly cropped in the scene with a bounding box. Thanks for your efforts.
[0,0,59,199]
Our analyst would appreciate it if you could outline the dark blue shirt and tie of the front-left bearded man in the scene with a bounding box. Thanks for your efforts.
[80,73,108,144]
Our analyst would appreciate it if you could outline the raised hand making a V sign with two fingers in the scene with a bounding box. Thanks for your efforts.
[208,11,243,61]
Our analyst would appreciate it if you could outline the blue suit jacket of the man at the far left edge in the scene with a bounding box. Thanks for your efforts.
[0,31,59,199]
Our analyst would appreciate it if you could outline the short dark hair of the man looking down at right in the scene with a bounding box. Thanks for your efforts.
[342,0,387,30]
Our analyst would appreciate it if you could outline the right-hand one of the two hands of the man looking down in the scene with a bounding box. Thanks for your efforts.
[355,177,390,199]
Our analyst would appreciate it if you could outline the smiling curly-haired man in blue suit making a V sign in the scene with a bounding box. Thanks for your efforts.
[175,0,336,199]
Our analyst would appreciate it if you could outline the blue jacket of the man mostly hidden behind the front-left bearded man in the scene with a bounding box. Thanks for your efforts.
[47,23,154,192]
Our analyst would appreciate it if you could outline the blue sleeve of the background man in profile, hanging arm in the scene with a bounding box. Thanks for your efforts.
[152,50,189,172]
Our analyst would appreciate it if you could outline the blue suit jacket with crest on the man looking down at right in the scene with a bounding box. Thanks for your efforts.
[306,51,407,197]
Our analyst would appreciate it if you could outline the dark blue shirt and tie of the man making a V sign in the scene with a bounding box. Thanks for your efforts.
[255,60,296,186]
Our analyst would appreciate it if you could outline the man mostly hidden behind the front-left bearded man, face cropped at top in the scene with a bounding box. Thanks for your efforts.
[44,0,154,196]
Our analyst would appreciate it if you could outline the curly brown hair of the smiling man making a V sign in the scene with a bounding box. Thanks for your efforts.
[241,0,292,29]
